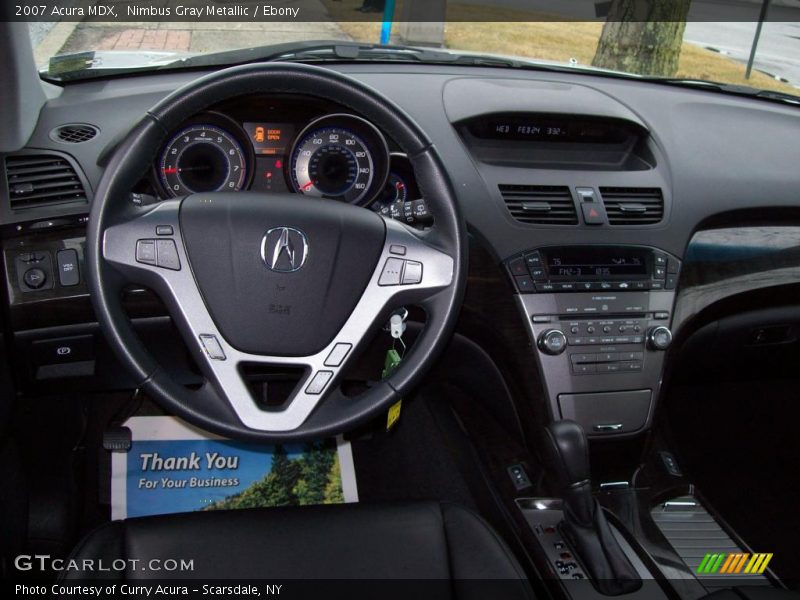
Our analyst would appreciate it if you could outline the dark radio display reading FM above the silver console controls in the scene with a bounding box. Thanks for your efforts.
[542,246,649,281]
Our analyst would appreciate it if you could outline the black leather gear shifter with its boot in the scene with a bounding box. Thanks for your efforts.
[544,420,642,596]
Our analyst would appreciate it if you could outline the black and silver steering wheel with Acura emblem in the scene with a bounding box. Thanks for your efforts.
[87,63,467,442]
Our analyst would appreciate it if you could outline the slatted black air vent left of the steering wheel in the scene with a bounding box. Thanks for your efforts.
[6,154,87,210]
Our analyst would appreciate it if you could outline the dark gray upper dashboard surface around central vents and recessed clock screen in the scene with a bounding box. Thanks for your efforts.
[6,64,800,260]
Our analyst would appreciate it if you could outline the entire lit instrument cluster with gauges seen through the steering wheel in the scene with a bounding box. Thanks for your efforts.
[152,106,432,226]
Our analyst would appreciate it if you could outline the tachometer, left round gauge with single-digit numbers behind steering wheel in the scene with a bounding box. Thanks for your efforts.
[158,125,247,196]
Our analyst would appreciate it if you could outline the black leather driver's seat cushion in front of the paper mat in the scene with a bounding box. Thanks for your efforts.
[64,502,533,599]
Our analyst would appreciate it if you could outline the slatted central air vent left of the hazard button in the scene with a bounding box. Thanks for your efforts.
[498,185,578,225]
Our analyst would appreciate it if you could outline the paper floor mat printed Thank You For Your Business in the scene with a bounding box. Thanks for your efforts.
[111,417,358,519]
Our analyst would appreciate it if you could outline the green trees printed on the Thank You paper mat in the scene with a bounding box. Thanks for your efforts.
[203,440,344,510]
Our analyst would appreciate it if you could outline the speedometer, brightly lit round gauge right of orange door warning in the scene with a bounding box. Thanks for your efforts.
[290,115,388,204]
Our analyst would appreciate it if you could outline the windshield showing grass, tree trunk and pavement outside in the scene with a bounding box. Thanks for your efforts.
[29,0,800,95]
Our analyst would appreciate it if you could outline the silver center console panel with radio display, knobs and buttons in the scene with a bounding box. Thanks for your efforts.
[506,245,680,437]
